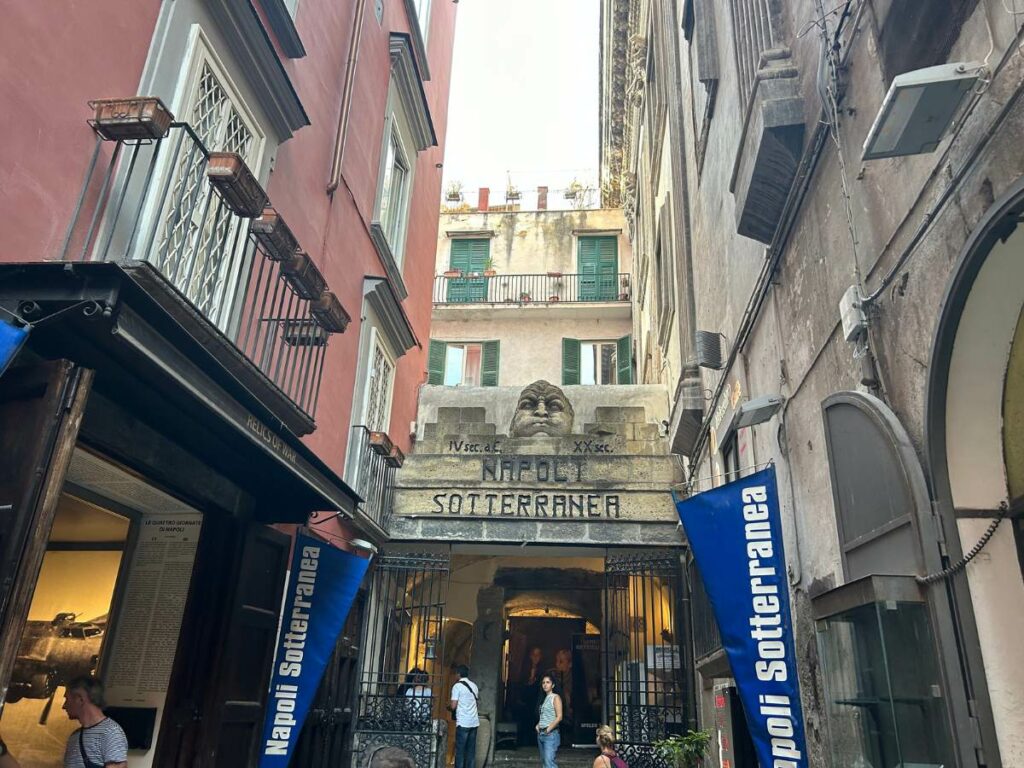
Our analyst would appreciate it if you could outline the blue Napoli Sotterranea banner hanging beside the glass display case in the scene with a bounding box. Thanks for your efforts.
[676,467,807,768]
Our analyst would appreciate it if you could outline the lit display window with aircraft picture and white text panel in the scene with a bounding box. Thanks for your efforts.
[0,447,203,768]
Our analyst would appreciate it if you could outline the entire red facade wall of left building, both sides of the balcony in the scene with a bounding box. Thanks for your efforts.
[0,0,456,481]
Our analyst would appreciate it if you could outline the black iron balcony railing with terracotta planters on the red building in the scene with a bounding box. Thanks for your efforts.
[60,123,348,420]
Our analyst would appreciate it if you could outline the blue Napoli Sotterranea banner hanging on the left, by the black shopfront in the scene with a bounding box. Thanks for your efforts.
[259,534,370,768]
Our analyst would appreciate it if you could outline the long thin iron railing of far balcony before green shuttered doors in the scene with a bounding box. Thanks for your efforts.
[434,272,631,304]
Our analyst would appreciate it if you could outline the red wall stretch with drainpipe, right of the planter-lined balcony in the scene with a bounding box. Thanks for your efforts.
[267,0,456,474]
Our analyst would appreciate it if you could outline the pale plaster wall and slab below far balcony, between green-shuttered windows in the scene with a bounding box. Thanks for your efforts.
[430,306,632,387]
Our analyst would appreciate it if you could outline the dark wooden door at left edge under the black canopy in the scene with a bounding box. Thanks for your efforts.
[0,360,92,707]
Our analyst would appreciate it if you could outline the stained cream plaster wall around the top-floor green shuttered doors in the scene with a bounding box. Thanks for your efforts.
[434,209,632,274]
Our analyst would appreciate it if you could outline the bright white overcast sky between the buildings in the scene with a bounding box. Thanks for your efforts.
[444,0,600,208]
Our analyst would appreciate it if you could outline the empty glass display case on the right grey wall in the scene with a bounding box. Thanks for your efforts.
[814,577,954,768]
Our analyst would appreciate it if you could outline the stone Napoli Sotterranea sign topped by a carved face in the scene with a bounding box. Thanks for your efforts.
[392,381,679,543]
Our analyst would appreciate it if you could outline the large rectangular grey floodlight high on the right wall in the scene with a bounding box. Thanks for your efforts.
[862,61,984,160]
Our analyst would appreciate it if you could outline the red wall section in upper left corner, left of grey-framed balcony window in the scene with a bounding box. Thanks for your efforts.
[0,0,160,261]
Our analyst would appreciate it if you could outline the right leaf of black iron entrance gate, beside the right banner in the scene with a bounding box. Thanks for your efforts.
[604,552,687,768]
